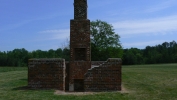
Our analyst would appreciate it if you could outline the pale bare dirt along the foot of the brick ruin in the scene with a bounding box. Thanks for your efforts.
[54,86,130,95]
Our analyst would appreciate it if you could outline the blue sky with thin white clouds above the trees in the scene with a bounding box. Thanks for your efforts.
[0,0,177,51]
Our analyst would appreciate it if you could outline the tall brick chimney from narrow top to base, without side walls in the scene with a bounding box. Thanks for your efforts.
[69,0,91,91]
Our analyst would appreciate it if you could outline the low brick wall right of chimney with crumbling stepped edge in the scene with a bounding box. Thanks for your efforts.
[84,58,122,91]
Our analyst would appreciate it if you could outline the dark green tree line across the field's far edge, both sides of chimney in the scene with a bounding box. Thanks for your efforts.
[0,41,177,67]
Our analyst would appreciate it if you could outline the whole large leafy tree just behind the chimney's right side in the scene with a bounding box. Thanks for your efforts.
[90,20,123,60]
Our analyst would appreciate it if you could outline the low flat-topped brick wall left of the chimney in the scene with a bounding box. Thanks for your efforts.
[28,58,65,90]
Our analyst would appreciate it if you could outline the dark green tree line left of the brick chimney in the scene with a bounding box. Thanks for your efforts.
[0,48,70,67]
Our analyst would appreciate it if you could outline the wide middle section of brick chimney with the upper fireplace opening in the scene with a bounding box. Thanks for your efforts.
[70,20,91,61]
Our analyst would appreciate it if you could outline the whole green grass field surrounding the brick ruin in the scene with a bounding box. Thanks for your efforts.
[0,64,177,100]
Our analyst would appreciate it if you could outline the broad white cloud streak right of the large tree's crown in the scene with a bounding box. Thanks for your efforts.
[112,15,177,35]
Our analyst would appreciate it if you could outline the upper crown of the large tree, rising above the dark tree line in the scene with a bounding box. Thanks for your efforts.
[90,20,122,48]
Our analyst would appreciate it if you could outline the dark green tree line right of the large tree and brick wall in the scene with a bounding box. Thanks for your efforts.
[123,41,177,65]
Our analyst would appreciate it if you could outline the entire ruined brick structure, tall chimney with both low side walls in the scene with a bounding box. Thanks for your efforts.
[28,0,122,91]
